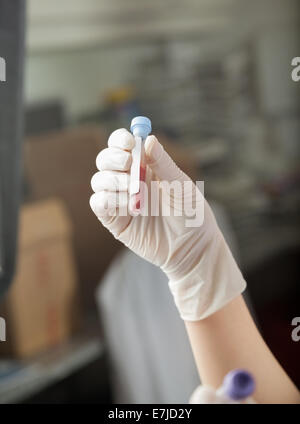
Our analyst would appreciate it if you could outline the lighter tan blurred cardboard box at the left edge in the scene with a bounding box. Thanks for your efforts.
[0,199,77,358]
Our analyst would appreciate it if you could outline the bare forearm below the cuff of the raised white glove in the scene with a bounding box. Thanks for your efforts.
[185,295,300,403]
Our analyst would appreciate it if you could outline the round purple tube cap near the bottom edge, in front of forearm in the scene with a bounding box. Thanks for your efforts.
[223,370,255,400]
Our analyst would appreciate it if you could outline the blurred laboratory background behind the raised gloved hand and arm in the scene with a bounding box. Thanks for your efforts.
[0,0,300,403]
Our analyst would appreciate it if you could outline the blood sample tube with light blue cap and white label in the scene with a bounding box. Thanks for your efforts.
[129,116,152,215]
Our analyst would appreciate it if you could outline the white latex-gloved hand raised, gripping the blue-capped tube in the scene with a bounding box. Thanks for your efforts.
[90,129,246,321]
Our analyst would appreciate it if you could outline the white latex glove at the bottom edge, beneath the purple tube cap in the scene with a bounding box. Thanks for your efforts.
[189,386,255,404]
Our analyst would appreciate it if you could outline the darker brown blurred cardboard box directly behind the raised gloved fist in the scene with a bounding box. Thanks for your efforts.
[24,126,121,316]
